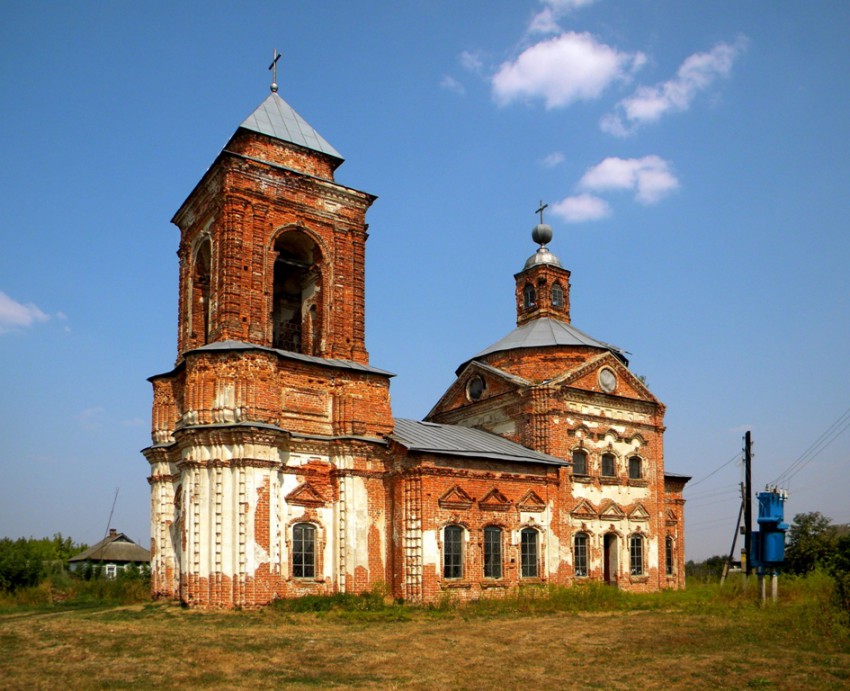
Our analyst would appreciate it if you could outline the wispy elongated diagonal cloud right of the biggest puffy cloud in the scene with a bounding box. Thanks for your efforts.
[599,37,747,137]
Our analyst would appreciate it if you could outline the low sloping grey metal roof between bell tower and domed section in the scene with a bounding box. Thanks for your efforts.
[390,418,569,465]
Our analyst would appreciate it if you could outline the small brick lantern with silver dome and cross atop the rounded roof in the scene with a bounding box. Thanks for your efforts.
[514,200,570,326]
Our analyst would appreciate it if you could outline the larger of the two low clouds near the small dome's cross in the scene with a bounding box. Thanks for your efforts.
[578,156,679,204]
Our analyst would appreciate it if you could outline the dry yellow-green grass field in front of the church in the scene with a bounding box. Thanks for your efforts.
[0,578,850,689]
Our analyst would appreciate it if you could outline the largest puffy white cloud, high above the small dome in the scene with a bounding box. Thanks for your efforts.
[492,32,645,108]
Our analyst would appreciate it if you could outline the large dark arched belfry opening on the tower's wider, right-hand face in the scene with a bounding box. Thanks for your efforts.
[272,230,324,355]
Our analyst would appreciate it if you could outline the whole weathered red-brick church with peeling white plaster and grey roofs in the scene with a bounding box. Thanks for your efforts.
[143,85,689,607]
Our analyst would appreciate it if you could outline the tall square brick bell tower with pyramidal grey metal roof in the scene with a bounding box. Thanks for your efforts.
[143,73,393,606]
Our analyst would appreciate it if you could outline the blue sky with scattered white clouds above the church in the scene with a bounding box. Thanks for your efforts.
[0,0,850,560]
